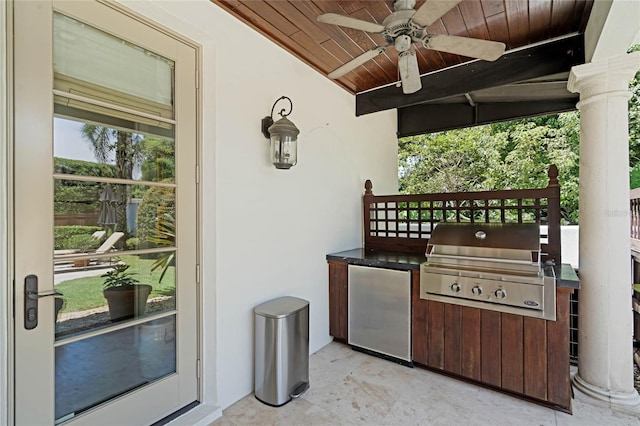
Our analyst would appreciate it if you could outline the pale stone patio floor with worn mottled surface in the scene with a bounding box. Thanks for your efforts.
[212,343,640,426]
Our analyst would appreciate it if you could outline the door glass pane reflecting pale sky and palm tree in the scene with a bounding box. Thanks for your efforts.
[53,117,175,182]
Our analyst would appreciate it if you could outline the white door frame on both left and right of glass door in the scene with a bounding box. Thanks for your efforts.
[0,0,222,425]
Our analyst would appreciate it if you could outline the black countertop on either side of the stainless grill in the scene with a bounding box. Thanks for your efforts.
[327,248,580,289]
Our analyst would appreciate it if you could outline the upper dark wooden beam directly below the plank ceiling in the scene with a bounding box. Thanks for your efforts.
[356,34,584,116]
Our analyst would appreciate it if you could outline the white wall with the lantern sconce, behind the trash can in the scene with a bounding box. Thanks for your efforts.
[122,0,397,408]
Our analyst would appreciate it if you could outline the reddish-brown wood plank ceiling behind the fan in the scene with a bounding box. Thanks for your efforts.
[211,0,593,94]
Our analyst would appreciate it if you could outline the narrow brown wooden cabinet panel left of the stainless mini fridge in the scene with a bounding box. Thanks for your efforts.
[328,261,349,343]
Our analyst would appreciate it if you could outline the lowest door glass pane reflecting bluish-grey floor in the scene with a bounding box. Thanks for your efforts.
[55,315,176,423]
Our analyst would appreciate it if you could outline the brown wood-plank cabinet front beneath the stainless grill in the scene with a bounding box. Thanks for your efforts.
[412,271,572,411]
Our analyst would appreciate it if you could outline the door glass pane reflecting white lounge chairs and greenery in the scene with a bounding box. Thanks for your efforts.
[53,179,176,256]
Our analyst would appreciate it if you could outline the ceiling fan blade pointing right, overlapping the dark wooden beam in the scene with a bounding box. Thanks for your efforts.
[425,34,506,61]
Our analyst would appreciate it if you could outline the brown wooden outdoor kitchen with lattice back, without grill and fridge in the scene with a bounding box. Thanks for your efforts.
[327,166,578,412]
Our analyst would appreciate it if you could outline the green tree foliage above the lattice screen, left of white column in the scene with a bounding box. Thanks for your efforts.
[399,112,580,223]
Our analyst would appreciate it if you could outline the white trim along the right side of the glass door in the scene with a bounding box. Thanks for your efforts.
[117,0,222,420]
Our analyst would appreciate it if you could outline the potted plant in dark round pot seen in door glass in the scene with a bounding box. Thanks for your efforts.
[101,263,152,321]
